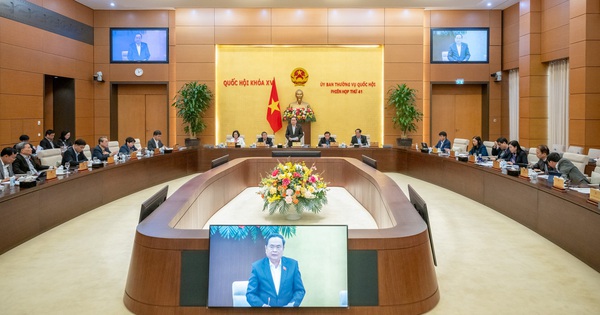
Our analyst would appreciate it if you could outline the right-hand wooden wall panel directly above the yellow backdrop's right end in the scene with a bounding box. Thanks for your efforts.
[329,26,385,45]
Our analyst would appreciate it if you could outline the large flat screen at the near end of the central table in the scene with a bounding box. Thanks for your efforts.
[208,225,348,308]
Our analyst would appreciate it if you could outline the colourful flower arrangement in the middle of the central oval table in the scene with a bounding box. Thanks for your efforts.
[258,161,328,214]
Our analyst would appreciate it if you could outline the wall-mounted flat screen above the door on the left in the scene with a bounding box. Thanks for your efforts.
[110,28,169,63]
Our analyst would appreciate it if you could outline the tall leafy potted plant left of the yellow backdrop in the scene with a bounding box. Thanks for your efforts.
[172,81,213,147]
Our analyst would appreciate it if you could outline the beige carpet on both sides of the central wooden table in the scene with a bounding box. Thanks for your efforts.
[0,173,600,315]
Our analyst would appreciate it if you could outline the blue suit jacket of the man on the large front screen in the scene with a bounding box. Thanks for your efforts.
[246,257,306,307]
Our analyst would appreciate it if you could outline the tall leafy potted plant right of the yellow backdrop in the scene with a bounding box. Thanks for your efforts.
[387,83,423,147]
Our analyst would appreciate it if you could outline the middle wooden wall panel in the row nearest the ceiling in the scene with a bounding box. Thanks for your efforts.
[271,8,328,28]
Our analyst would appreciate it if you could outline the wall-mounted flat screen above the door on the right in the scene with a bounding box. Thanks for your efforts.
[430,28,490,63]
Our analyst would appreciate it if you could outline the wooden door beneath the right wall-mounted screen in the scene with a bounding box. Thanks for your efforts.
[431,84,483,143]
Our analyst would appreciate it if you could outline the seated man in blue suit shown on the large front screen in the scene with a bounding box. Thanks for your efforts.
[246,234,306,307]
